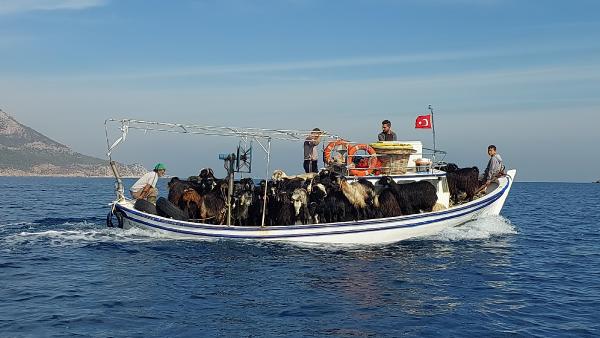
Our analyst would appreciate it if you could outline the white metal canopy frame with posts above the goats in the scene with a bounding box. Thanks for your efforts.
[104,118,342,226]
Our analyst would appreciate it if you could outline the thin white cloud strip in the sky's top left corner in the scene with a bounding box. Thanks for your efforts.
[0,0,108,14]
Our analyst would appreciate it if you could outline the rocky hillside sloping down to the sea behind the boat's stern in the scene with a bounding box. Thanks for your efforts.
[0,110,146,177]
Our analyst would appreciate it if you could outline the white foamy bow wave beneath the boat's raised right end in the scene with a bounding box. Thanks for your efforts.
[423,216,517,242]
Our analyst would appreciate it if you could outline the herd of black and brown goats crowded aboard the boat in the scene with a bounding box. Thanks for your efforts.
[135,164,479,226]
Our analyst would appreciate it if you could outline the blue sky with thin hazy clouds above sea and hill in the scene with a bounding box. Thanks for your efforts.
[0,0,600,182]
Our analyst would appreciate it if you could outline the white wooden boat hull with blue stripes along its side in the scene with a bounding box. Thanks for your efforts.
[115,170,516,244]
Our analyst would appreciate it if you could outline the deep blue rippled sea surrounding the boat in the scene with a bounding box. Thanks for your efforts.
[0,177,600,337]
